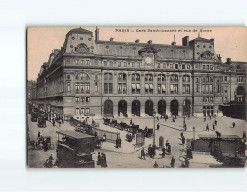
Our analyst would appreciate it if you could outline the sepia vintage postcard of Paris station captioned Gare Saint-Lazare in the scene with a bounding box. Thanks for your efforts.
[26,26,247,168]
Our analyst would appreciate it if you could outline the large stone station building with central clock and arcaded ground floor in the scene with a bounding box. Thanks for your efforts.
[33,28,246,117]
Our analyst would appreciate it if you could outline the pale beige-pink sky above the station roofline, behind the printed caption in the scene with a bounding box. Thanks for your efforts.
[27,26,247,80]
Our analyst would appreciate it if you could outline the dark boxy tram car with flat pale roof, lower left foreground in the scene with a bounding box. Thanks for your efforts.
[56,131,95,168]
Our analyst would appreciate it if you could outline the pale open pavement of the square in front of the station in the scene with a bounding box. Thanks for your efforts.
[28,115,246,168]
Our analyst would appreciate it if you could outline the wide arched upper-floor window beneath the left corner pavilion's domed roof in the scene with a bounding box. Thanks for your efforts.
[75,72,90,94]
